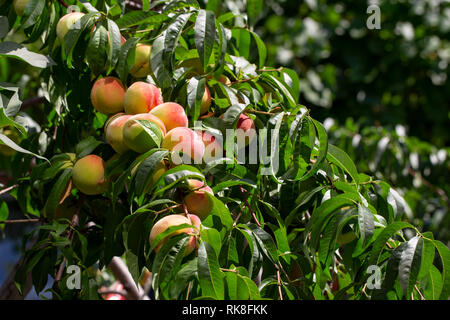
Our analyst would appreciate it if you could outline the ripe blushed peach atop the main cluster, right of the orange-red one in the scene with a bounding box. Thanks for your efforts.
[124,81,164,114]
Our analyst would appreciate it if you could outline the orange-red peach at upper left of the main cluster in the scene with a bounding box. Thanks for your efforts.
[91,77,125,114]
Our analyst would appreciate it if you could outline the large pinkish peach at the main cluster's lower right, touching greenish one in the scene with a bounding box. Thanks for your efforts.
[161,127,205,164]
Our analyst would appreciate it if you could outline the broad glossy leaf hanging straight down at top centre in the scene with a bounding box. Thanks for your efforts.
[194,10,216,70]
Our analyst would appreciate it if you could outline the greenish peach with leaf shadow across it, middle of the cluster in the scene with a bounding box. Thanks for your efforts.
[123,113,166,153]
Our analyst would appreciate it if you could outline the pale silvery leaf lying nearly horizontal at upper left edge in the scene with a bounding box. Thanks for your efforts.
[0,41,56,68]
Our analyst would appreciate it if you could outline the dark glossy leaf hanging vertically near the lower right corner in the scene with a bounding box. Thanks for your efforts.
[398,237,423,299]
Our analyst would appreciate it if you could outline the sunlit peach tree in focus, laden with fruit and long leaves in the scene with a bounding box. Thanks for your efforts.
[0,0,450,300]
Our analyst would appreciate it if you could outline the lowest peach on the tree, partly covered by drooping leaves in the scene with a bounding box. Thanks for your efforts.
[149,214,201,256]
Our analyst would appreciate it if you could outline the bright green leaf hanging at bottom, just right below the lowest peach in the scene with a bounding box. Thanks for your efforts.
[197,242,225,300]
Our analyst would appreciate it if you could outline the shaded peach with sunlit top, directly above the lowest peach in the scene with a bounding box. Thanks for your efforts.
[184,179,214,220]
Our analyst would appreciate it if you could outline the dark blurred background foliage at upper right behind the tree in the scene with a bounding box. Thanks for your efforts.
[200,0,450,244]
